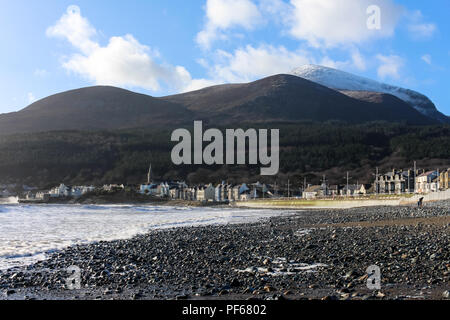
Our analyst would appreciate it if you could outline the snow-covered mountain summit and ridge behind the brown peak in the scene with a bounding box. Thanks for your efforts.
[291,65,450,123]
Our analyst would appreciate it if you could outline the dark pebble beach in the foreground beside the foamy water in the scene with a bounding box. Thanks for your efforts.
[0,201,450,300]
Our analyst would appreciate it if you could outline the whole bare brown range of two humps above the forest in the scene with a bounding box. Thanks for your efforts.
[0,75,436,135]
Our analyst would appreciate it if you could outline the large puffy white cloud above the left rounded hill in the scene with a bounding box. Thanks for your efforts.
[47,6,200,91]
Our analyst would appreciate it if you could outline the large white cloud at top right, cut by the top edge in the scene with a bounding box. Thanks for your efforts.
[289,0,403,47]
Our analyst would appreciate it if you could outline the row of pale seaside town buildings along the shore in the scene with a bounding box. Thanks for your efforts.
[0,165,450,203]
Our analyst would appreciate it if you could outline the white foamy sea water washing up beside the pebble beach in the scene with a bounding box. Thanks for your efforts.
[0,204,293,269]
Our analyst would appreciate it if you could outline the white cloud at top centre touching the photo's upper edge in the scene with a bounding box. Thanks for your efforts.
[196,0,262,48]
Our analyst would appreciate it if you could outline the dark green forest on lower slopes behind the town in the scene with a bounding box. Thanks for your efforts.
[0,122,450,188]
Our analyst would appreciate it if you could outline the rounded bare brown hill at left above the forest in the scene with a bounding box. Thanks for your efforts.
[0,86,193,134]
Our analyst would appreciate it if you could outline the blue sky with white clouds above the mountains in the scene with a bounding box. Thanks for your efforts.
[0,0,450,115]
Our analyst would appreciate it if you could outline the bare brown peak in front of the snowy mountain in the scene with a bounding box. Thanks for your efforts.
[162,75,434,124]
